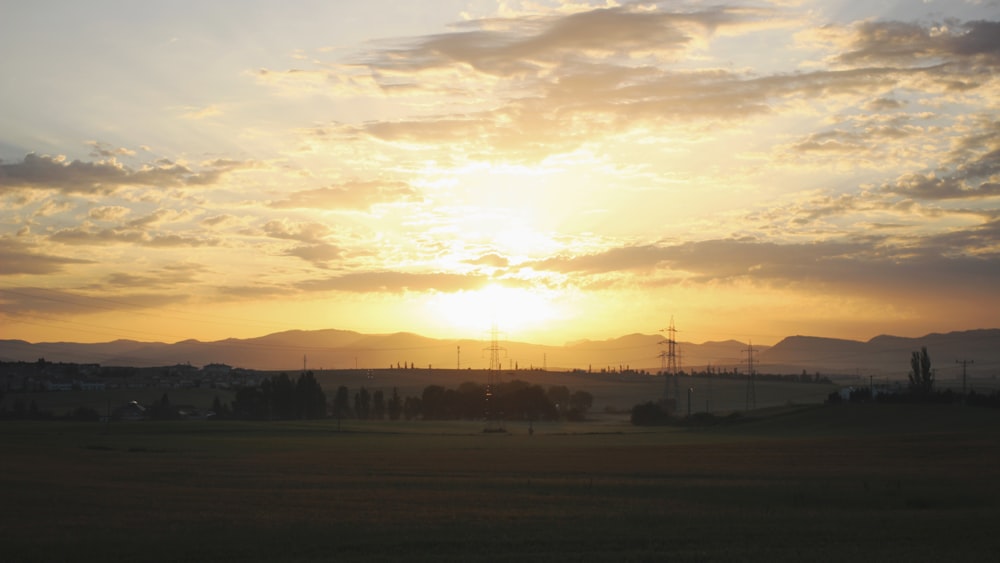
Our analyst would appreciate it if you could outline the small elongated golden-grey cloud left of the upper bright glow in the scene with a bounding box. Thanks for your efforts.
[271,181,420,210]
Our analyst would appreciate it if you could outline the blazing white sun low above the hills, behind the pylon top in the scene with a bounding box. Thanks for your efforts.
[428,283,557,338]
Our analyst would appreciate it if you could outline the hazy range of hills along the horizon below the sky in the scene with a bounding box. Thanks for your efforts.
[0,329,1000,377]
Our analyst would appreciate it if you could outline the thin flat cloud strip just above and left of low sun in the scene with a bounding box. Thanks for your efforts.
[296,272,489,293]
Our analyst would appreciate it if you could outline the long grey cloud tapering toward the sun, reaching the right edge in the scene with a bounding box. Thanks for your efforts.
[530,235,1000,303]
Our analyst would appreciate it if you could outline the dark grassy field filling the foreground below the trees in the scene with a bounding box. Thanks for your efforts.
[0,405,1000,562]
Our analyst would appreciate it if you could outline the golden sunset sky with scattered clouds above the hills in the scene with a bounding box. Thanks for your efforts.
[0,0,1000,344]
